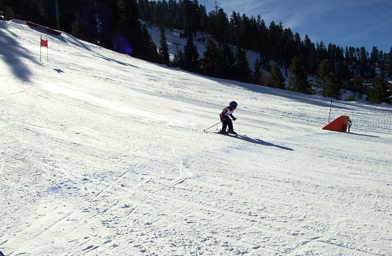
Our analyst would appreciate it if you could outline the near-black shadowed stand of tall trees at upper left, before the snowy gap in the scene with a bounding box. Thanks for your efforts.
[0,0,160,62]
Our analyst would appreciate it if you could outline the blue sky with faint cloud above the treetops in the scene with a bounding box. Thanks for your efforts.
[199,0,392,53]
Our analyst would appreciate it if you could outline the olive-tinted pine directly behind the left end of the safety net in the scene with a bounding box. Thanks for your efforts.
[315,59,340,99]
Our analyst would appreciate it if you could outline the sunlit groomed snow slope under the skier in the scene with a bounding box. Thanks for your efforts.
[0,21,392,255]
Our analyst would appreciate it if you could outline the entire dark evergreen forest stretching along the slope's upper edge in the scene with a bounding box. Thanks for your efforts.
[0,0,392,103]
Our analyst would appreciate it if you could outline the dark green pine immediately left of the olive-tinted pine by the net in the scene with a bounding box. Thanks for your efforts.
[289,57,312,94]
